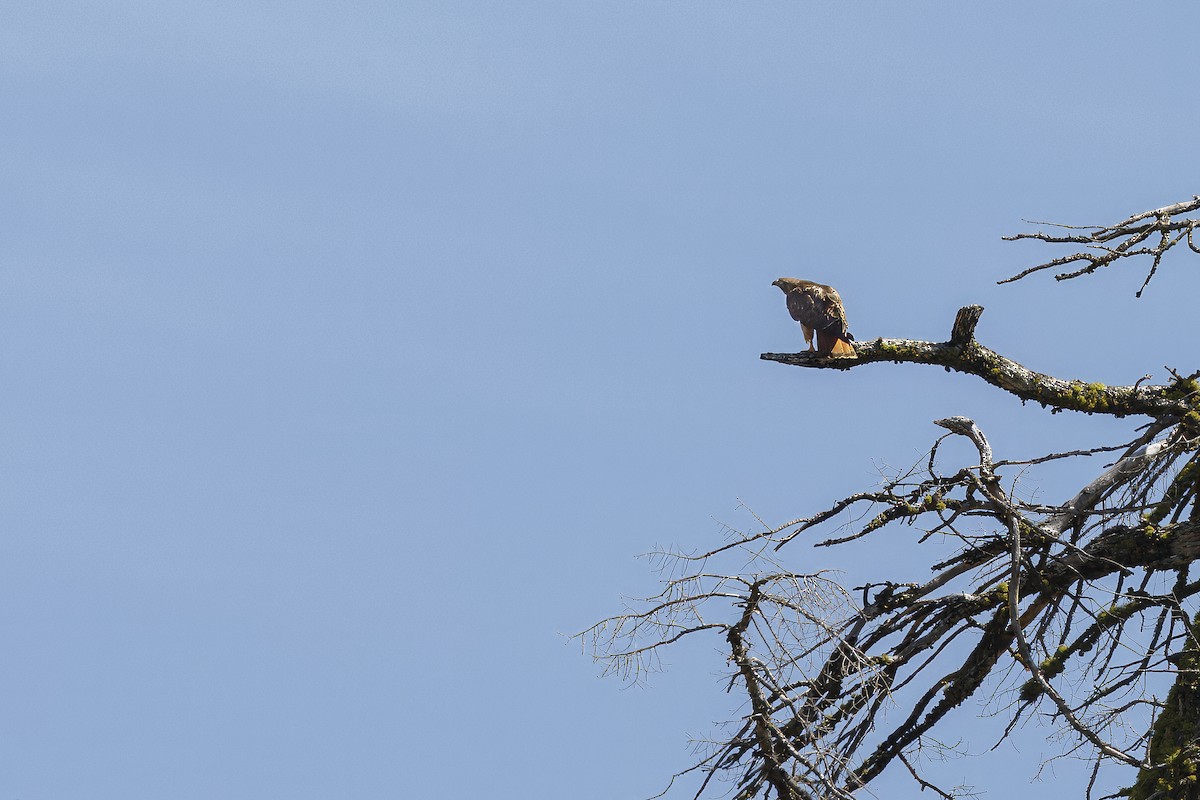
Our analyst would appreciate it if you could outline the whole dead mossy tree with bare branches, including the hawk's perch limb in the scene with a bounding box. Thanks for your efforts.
[578,197,1200,800]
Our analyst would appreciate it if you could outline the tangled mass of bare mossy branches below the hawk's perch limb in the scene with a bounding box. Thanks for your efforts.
[581,417,1200,798]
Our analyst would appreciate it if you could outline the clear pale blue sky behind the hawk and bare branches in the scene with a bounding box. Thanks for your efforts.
[0,0,1200,800]
